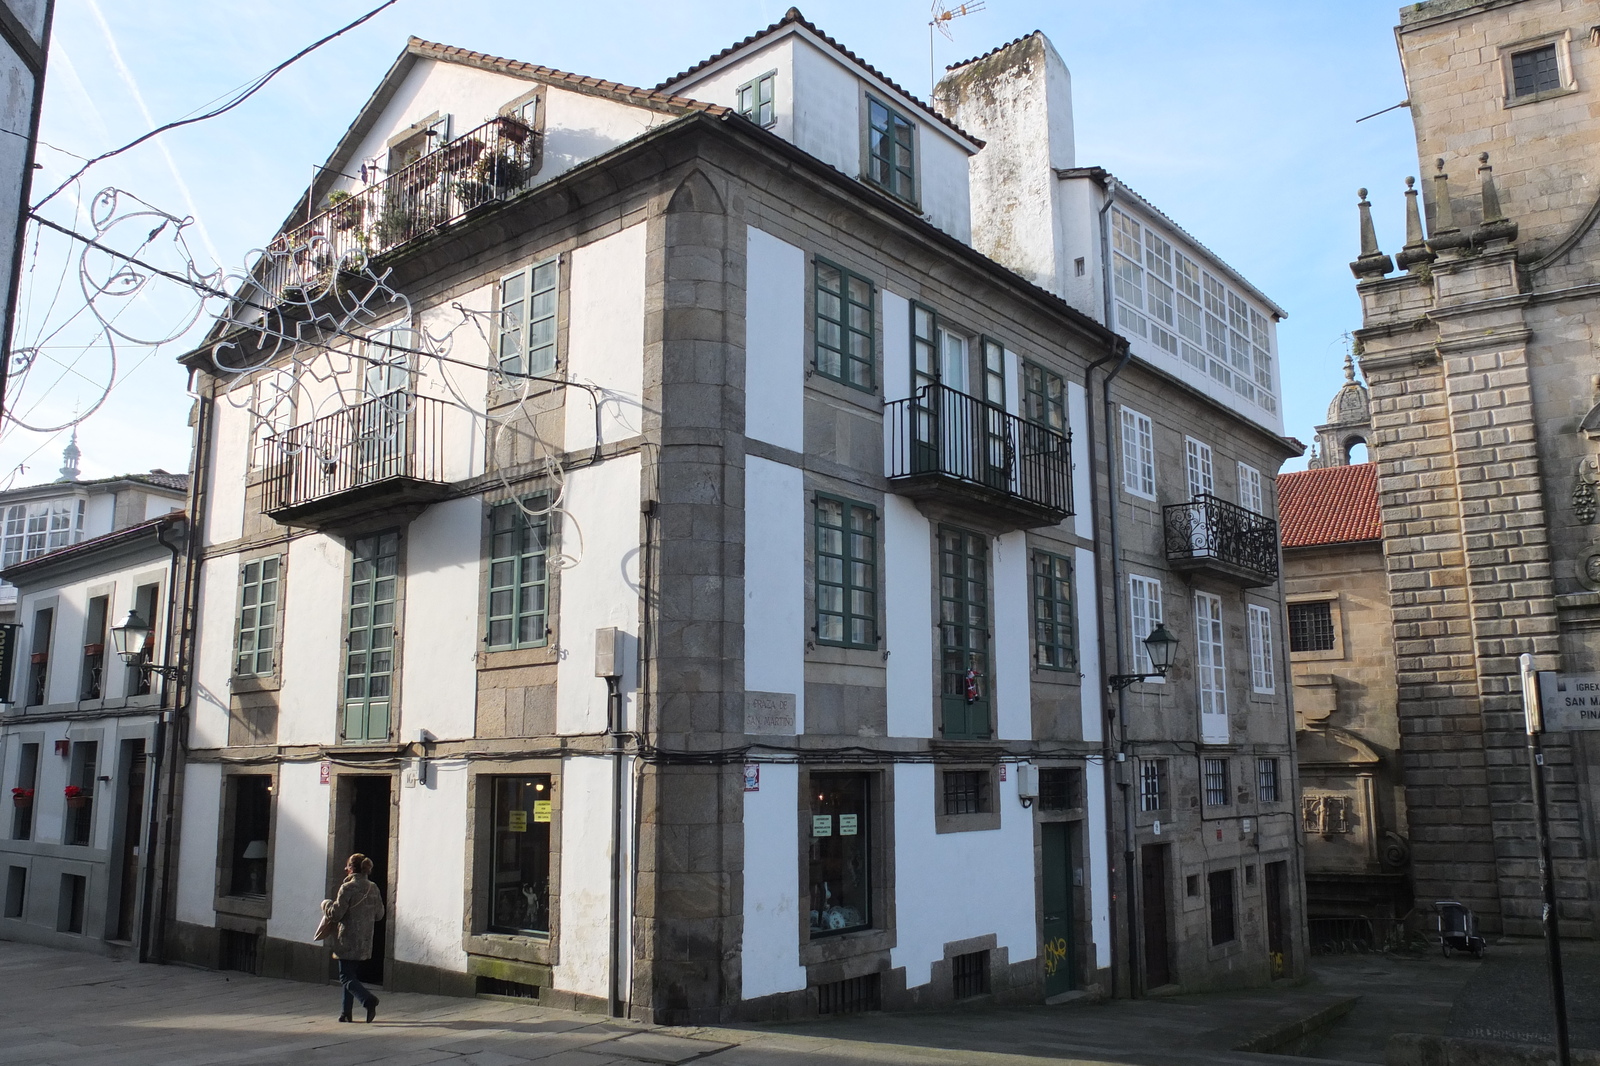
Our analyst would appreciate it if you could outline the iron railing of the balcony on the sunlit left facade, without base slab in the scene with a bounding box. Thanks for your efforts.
[262,392,445,514]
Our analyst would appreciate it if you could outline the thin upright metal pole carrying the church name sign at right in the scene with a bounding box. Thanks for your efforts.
[1518,653,1568,1066]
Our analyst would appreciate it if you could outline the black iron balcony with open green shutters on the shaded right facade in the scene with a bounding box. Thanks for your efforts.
[883,384,1072,528]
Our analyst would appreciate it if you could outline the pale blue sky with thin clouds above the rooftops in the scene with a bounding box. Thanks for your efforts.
[0,0,1418,485]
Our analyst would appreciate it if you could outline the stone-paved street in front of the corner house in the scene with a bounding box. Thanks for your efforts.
[0,941,1480,1066]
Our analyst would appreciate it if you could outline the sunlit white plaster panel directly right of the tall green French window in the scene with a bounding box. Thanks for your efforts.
[398,496,483,739]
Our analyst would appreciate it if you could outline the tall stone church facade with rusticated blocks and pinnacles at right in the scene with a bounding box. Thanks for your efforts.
[1352,0,1600,935]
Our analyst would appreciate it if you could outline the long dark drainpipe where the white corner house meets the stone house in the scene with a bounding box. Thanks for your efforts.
[1085,174,1141,999]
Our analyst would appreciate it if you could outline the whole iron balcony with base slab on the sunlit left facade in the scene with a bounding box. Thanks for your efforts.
[262,392,450,527]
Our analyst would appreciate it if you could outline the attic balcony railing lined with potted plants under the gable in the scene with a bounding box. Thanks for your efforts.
[262,118,539,303]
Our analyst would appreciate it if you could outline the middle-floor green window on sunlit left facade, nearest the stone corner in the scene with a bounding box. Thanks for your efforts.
[483,496,550,650]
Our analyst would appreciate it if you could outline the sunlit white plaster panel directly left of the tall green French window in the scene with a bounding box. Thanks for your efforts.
[278,533,347,744]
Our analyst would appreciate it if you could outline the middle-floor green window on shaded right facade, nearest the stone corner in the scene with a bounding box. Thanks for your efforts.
[814,493,878,648]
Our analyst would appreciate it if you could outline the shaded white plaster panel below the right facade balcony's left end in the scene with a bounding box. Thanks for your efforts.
[883,496,933,736]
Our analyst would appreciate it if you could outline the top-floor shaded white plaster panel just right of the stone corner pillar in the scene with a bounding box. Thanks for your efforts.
[744,227,805,451]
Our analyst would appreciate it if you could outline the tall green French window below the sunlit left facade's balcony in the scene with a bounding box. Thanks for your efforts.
[341,530,400,743]
